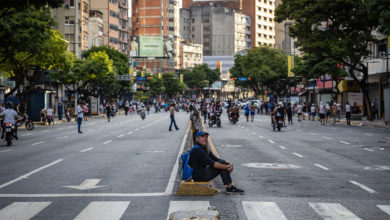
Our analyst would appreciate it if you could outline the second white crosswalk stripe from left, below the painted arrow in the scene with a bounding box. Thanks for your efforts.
[75,201,130,220]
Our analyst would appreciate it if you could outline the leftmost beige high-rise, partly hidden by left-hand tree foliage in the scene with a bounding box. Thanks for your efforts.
[50,0,89,57]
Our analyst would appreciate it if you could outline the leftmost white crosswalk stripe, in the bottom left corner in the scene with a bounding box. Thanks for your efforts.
[0,202,51,220]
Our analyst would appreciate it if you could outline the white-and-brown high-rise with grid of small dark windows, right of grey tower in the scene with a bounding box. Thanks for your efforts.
[242,0,275,47]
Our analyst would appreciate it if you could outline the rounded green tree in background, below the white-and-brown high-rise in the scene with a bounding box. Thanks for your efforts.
[230,47,287,94]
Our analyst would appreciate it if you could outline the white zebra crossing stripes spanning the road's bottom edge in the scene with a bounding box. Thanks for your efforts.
[0,200,390,220]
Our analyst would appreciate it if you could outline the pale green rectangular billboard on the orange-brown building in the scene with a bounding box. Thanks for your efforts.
[139,36,164,57]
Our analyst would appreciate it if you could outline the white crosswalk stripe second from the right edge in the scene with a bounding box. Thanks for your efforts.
[309,203,361,220]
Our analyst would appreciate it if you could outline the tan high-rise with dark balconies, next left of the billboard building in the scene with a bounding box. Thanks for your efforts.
[90,0,128,54]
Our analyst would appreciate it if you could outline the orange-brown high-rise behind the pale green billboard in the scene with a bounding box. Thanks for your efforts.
[130,0,179,73]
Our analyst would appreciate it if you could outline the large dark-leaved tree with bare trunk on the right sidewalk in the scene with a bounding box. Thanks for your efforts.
[276,0,388,120]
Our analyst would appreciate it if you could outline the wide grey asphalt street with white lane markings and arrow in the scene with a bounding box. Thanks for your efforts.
[0,109,390,220]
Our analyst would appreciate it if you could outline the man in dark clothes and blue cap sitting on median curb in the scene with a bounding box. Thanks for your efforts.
[188,131,244,194]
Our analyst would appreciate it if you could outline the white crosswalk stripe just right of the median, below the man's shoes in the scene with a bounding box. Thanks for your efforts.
[242,201,287,220]
